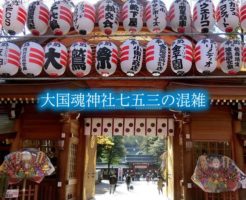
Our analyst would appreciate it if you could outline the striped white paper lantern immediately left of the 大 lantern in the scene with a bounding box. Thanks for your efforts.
[20,42,44,76]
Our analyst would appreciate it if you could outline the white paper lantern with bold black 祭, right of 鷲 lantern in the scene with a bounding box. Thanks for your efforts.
[96,42,118,76]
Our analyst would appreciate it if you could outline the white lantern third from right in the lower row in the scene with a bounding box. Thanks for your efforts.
[171,39,193,75]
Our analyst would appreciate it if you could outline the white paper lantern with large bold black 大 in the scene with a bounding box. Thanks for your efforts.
[44,42,68,77]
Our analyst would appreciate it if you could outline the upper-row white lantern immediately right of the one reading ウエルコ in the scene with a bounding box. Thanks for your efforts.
[216,0,239,32]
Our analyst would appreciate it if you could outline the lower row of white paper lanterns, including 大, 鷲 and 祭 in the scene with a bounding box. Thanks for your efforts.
[0,39,243,77]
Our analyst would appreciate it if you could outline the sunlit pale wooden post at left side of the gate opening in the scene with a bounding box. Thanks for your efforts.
[83,136,97,200]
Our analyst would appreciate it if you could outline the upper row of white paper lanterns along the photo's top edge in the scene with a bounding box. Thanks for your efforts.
[0,0,246,35]
